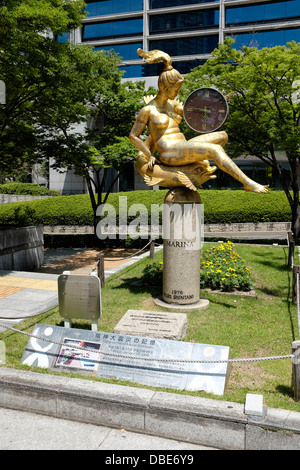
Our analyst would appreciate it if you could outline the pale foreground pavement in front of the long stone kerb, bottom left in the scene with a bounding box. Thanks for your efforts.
[0,407,216,450]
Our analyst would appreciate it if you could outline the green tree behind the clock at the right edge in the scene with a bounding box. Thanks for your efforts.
[182,38,300,238]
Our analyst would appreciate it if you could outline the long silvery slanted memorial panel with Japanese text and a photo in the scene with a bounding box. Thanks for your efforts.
[21,324,229,395]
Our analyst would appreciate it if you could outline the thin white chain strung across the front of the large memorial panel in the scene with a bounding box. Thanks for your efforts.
[0,323,296,364]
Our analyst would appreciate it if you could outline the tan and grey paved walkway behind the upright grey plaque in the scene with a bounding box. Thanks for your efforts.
[0,248,159,332]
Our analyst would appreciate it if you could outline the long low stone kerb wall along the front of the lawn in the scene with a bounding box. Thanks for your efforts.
[0,367,300,450]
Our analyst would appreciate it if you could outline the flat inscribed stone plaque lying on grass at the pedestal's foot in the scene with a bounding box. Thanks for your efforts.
[114,310,188,340]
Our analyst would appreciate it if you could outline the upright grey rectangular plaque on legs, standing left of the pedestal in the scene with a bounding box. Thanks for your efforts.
[57,274,101,320]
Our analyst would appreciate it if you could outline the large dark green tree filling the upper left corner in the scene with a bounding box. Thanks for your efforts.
[0,0,85,176]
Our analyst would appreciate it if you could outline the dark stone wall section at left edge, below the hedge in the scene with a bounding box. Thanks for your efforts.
[0,226,44,271]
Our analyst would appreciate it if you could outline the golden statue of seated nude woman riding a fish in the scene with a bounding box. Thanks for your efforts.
[129,49,268,193]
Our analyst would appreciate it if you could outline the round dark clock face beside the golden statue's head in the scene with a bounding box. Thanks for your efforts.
[183,88,229,133]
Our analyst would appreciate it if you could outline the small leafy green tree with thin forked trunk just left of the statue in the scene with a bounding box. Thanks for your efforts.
[45,76,149,218]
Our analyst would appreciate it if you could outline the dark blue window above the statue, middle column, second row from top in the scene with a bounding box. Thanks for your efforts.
[150,9,219,34]
